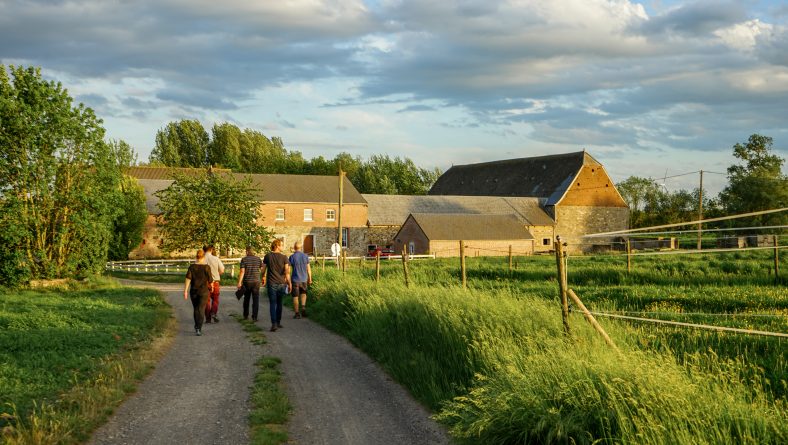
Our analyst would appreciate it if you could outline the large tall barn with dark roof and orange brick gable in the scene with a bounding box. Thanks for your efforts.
[429,151,629,251]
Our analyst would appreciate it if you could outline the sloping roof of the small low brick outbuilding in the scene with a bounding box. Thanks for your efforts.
[395,213,534,241]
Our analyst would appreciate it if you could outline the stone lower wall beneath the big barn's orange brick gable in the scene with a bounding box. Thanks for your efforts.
[555,206,629,252]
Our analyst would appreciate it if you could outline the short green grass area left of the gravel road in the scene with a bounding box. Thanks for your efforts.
[0,280,175,444]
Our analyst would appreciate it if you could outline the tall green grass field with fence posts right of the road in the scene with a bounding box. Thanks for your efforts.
[309,252,788,444]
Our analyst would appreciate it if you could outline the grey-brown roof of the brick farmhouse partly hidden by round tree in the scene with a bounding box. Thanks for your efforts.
[126,167,366,214]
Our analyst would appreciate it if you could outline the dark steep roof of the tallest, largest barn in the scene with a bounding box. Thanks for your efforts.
[429,151,601,205]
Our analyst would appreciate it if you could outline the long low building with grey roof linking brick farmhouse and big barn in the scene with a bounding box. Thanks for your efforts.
[361,194,555,255]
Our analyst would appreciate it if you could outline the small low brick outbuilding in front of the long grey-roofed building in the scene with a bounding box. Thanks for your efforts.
[393,213,534,257]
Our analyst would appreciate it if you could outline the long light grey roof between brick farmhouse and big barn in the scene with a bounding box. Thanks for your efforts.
[361,194,555,226]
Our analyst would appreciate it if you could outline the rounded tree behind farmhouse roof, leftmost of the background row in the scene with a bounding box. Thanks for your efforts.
[150,119,210,167]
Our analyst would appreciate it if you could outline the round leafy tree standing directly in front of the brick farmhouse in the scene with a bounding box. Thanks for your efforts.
[156,172,271,252]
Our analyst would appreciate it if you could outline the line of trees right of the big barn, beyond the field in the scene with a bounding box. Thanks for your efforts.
[616,134,788,228]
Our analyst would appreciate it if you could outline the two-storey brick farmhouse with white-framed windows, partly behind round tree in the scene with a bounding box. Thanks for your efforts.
[127,167,367,258]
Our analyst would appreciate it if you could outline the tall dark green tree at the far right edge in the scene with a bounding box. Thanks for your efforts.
[720,134,788,227]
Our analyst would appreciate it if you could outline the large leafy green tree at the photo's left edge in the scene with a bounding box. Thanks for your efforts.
[0,65,122,284]
